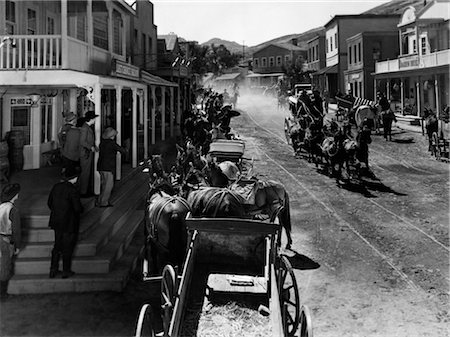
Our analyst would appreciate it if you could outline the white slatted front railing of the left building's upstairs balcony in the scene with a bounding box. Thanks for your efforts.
[0,35,61,70]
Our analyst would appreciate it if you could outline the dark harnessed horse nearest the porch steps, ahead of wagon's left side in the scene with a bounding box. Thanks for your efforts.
[143,173,191,277]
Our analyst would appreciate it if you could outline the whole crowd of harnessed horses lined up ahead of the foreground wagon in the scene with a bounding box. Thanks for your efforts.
[143,91,292,277]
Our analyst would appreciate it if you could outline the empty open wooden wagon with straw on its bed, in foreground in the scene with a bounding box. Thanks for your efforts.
[136,215,312,337]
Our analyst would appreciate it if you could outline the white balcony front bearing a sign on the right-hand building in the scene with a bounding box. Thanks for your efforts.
[375,49,450,74]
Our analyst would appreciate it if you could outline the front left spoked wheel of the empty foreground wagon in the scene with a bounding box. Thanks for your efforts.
[161,264,177,336]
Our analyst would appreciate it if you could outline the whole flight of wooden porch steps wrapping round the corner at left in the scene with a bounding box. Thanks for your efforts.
[8,169,148,294]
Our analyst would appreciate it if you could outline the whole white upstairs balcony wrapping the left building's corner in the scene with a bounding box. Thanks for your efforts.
[0,35,126,74]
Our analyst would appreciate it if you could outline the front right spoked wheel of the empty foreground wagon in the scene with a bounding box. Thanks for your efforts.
[278,256,300,336]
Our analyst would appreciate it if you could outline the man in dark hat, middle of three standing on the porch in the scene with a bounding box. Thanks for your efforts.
[79,111,98,198]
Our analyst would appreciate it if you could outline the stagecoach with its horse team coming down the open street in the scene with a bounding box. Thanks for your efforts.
[285,93,372,183]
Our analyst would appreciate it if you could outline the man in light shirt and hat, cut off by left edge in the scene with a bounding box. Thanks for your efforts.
[0,184,21,299]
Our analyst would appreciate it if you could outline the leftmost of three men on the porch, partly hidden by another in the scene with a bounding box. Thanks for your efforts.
[58,113,80,174]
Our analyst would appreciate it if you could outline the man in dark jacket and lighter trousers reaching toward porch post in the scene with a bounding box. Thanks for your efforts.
[97,127,126,207]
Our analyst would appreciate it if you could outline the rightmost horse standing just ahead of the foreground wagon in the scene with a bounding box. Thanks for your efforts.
[207,161,292,249]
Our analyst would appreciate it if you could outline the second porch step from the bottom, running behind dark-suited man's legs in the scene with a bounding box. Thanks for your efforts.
[14,211,142,275]
